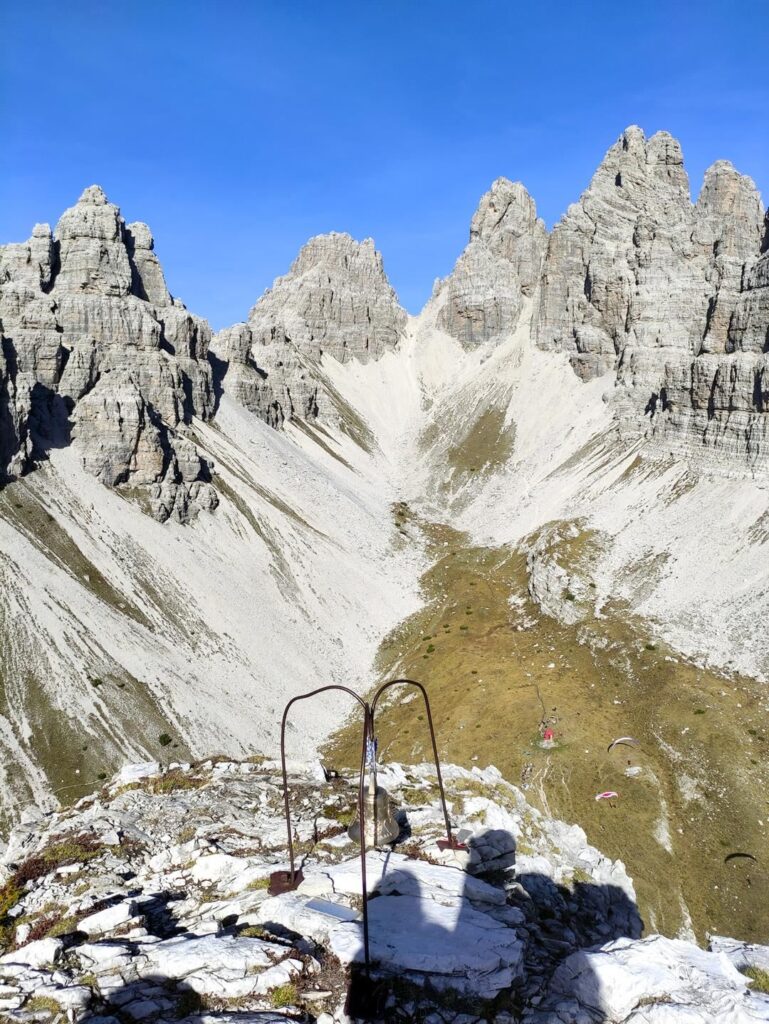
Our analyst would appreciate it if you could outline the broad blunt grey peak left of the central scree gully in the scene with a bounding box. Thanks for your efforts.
[212,232,407,426]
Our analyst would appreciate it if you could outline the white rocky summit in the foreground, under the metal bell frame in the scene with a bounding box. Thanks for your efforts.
[0,759,769,1024]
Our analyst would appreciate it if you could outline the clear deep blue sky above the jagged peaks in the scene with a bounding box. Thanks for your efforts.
[0,0,769,328]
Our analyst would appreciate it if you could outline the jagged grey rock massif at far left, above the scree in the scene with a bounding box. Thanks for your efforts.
[0,185,217,519]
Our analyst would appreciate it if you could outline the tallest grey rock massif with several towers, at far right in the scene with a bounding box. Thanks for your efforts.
[533,128,769,472]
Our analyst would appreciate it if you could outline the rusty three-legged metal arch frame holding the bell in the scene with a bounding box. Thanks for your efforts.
[269,679,466,975]
